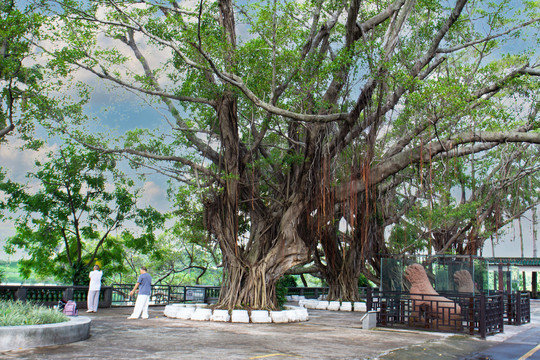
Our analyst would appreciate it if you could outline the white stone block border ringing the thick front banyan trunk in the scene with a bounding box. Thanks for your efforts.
[163,304,309,324]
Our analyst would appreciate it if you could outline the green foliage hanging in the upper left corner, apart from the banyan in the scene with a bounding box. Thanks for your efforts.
[0,0,68,144]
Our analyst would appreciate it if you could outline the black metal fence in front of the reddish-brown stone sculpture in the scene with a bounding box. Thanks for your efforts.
[366,291,504,338]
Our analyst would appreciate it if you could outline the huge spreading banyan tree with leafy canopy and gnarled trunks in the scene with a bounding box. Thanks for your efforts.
[11,0,540,308]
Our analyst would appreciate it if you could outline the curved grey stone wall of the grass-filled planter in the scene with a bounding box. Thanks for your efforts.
[0,316,92,351]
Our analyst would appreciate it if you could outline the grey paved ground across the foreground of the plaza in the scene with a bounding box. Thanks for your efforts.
[0,301,540,360]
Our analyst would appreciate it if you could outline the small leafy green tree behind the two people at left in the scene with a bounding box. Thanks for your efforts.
[0,145,164,285]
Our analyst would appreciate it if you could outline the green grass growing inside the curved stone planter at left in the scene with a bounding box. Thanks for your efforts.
[0,301,69,326]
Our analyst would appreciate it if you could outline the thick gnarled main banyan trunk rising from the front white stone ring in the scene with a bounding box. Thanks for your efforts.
[205,93,307,309]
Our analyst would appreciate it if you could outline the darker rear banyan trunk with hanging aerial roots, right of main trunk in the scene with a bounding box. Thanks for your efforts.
[309,155,384,301]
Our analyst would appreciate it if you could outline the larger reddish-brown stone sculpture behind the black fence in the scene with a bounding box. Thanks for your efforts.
[405,264,461,330]
